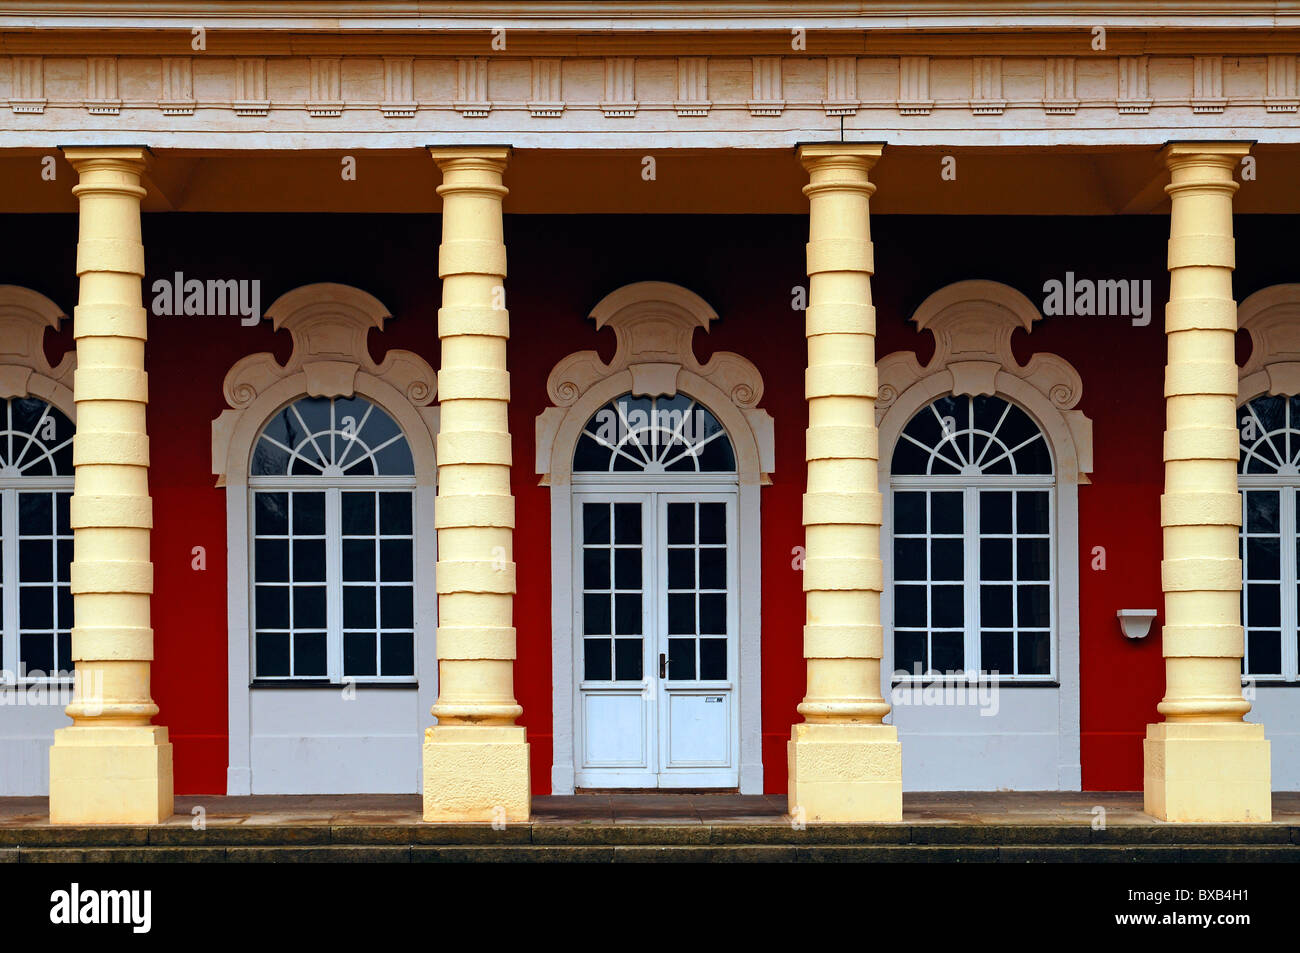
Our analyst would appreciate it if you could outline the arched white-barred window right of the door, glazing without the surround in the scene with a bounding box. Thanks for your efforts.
[889,395,1056,680]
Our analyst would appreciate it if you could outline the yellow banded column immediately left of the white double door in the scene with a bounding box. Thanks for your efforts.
[424,147,530,822]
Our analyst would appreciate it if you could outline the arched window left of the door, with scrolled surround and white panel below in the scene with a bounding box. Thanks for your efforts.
[212,283,438,794]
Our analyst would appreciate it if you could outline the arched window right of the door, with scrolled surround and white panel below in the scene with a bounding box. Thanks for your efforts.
[876,281,1097,790]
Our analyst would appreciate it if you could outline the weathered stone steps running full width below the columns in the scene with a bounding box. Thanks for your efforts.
[0,822,1300,863]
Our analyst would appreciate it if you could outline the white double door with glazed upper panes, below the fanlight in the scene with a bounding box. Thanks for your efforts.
[573,488,740,788]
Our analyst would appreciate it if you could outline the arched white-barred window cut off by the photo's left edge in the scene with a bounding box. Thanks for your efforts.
[0,397,73,681]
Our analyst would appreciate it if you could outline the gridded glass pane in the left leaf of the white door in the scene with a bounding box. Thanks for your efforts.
[581,503,645,681]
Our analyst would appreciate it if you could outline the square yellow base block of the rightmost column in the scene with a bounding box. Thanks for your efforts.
[1143,722,1273,824]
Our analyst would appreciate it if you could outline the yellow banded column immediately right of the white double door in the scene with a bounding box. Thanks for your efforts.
[787,143,902,823]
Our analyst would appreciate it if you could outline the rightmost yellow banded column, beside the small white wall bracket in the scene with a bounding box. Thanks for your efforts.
[1143,143,1271,823]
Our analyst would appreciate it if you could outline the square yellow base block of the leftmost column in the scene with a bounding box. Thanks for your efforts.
[49,724,174,824]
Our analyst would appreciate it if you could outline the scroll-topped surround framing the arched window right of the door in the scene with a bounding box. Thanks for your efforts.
[876,280,1092,789]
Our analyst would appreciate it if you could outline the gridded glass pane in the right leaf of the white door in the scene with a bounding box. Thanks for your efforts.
[666,503,731,681]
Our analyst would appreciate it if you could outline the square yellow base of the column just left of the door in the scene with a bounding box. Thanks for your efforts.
[424,725,532,823]
